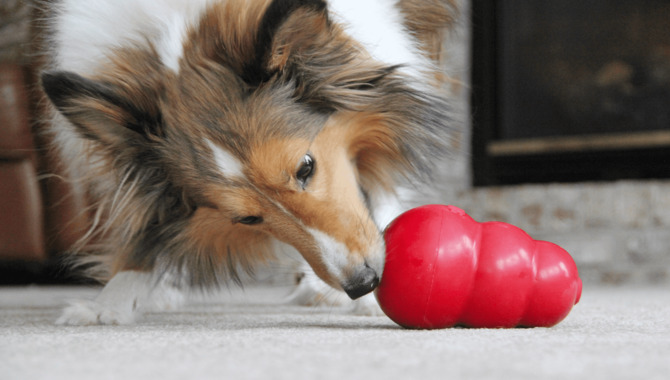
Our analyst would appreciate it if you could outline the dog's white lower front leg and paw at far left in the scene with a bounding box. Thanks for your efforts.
[56,271,157,325]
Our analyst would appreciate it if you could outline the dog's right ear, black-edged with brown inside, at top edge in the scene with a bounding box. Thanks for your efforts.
[242,0,330,84]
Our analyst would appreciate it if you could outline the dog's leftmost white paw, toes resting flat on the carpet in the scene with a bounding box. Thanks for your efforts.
[56,301,134,326]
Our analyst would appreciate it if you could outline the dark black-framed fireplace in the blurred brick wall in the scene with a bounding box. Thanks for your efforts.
[472,0,670,186]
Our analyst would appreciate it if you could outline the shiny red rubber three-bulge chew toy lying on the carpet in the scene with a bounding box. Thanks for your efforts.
[376,205,582,329]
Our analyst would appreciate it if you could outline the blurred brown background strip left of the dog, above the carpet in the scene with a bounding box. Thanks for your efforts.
[0,0,92,284]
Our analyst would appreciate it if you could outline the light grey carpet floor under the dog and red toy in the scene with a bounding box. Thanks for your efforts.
[0,286,670,380]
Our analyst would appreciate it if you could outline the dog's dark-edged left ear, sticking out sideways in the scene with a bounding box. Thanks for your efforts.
[41,71,162,146]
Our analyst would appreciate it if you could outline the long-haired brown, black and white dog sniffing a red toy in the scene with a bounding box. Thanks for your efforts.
[41,0,456,325]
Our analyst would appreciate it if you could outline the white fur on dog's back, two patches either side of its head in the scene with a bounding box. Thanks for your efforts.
[53,0,431,78]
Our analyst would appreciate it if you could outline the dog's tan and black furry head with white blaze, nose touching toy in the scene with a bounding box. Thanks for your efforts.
[42,0,448,298]
